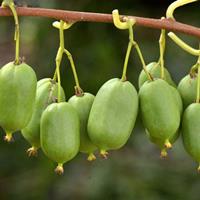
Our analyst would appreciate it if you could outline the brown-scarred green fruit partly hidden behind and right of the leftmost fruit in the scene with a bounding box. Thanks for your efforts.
[21,78,65,148]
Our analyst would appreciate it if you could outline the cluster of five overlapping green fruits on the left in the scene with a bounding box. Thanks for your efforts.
[0,59,138,173]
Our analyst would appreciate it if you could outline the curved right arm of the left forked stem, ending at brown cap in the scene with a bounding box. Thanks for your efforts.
[64,49,83,96]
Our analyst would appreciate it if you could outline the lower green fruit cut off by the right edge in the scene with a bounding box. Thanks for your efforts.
[182,103,200,163]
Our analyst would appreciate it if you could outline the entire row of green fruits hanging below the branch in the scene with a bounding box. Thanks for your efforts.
[0,57,200,173]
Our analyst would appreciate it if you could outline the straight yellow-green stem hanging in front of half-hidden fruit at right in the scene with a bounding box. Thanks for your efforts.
[159,26,166,79]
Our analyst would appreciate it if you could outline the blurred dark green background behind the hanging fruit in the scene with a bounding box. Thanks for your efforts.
[0,0,200,200]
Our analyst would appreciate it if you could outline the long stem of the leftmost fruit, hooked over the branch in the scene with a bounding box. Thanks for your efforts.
[2,0,20,65]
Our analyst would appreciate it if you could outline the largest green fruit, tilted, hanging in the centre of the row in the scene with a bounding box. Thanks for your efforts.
[88,78,138,150]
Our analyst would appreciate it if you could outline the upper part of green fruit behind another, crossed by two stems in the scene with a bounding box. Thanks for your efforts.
[138,62,176,88]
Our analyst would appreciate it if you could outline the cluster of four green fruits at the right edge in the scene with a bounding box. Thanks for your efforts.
[139,61,200,170]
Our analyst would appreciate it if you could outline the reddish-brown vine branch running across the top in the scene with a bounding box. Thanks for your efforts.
[0,7,200,38]
